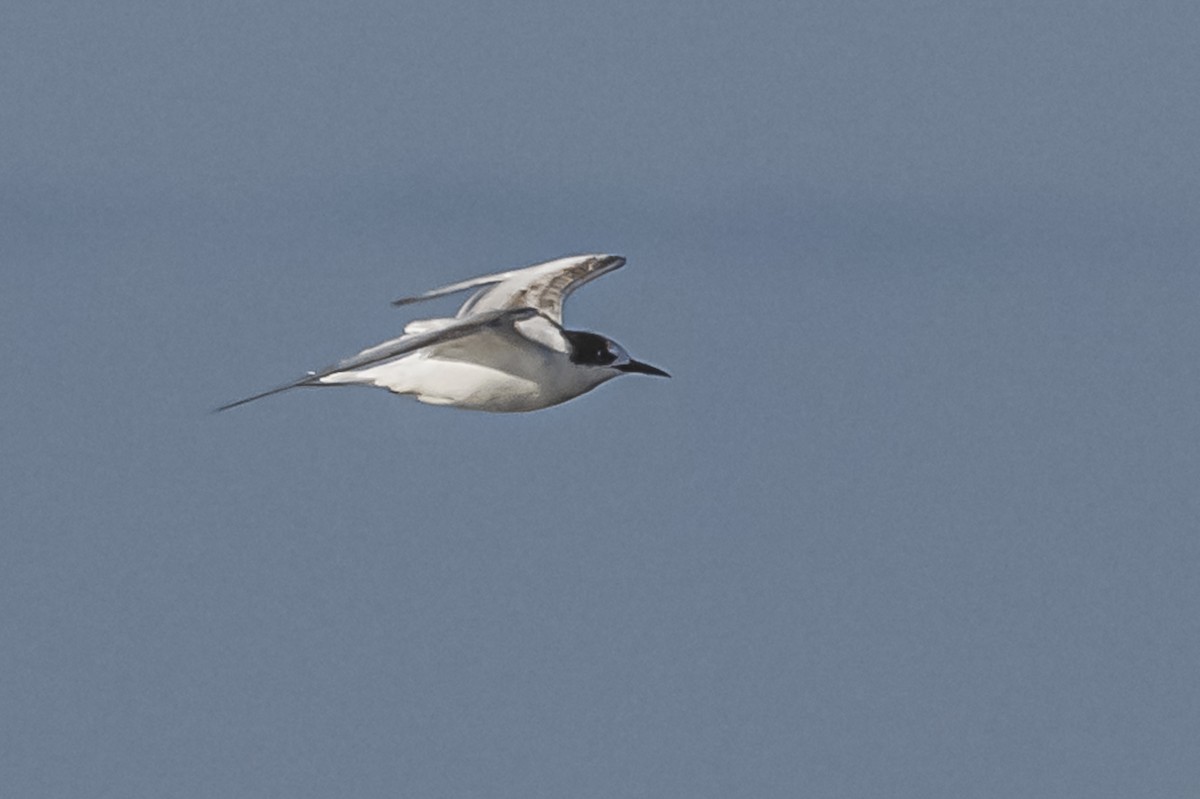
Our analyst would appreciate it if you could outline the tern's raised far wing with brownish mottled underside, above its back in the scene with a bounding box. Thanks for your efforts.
[392,254,625,325]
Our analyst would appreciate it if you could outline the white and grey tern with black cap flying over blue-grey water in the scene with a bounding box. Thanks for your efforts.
[217,254,671,413]
